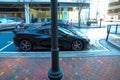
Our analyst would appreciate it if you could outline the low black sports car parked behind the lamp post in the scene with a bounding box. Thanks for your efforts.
[14,26,90,51]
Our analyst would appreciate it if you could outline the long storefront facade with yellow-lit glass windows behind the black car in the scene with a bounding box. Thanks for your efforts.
[0,0,90,23]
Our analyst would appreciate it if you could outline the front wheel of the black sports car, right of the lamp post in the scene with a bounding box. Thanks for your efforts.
[72,40,84,51]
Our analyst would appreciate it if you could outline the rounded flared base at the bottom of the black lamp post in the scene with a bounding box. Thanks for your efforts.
[48,69,63,80]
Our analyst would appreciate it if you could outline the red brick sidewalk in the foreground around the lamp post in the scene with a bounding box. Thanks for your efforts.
[0,56,120,80]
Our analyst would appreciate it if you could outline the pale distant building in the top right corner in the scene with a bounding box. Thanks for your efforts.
[108,0,120,19]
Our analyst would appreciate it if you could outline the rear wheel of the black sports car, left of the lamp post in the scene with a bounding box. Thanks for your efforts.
[20,40,33,51]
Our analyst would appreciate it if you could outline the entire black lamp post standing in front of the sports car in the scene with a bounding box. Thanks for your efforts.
[48,0,63,80]
